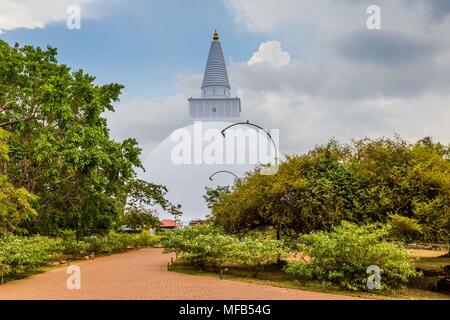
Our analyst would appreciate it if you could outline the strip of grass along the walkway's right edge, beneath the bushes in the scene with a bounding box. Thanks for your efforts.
[170,252,450,300]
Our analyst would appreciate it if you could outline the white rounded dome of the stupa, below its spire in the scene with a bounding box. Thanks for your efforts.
[143,121,274,220]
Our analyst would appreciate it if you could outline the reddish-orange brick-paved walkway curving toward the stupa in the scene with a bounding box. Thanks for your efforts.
[0,248,358,300]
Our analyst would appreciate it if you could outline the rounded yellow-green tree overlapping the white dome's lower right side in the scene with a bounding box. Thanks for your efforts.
[212,141,361,238]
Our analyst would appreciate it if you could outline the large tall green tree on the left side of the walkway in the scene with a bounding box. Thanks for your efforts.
[0,41,177,235]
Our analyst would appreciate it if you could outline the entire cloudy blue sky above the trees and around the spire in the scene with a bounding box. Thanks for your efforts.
[0,0,450,220]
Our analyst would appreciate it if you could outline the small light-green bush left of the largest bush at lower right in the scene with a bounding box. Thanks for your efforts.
[230,238,286,277]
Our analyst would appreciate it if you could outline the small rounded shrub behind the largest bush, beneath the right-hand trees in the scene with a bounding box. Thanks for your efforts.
[388,214,422,243]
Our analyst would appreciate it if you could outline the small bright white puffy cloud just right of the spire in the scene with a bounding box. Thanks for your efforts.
[247,41,291,68]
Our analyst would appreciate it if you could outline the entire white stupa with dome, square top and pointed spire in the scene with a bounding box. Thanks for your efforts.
[143,32,274,221]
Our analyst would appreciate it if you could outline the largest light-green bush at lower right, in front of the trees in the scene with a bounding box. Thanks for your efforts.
[285,222,419,291]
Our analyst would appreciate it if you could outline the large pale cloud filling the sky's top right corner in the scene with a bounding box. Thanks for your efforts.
[225,0,450,61]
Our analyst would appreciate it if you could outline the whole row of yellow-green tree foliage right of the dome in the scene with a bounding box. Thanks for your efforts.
[212,137,450,243]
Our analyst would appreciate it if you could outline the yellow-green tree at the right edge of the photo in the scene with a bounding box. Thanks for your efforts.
[351,137,450,243]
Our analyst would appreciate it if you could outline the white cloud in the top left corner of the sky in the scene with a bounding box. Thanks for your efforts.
[0,0,103,32]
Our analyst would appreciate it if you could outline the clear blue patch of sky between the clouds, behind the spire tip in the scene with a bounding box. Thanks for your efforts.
[0,0,265,98]
